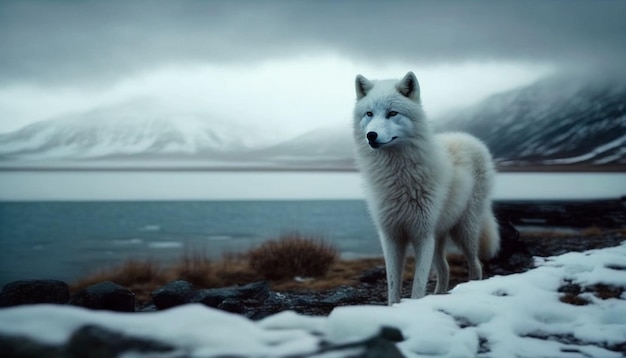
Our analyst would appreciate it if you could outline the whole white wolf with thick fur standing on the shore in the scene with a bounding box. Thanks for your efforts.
[354,72,500,305]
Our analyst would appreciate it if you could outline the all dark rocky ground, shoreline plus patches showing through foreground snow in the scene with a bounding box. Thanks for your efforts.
[0,198,626,358]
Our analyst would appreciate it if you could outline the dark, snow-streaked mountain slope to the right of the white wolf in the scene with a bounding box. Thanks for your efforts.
[438,76,626,169]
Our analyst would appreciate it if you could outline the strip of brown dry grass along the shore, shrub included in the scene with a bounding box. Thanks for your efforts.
[71,228,626,303]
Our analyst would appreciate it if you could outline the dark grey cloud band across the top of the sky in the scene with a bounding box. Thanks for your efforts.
[0,0,626,85]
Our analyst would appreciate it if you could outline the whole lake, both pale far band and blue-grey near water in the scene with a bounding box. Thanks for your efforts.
[0,172,626,285]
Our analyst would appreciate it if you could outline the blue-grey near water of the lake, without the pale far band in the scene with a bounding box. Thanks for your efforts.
[0,200,381,285]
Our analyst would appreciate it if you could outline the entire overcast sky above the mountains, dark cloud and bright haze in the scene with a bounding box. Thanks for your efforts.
[0,0,626,135]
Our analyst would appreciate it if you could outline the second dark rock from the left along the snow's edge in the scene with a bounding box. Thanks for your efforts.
[70,281,135,312]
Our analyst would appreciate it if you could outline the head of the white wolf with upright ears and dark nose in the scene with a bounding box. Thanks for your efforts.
[354,72,425,149]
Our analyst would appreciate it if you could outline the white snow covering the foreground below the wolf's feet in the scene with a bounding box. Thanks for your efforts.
[0,242,626,357]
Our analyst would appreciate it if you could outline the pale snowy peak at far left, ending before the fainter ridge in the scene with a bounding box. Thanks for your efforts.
[0,101,247,160]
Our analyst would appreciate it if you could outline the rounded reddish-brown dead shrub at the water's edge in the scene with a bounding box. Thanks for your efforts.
[248,234,338,280]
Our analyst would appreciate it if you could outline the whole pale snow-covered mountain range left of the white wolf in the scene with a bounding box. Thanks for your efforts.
[0,100,353,169]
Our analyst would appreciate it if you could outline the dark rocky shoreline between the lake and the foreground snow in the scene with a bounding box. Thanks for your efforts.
[0,198,626,320]
